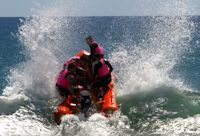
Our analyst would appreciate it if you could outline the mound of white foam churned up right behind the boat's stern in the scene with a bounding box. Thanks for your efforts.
[54,114,129,136]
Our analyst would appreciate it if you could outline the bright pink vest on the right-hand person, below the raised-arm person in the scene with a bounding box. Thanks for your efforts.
[97,59,110,77]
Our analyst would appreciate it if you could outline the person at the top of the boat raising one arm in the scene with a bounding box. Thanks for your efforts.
[85,36,103,62]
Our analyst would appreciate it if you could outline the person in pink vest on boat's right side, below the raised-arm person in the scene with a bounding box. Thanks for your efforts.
[92,53,113,99]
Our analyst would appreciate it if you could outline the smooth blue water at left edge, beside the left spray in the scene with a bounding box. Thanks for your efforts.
[0,17,24,93]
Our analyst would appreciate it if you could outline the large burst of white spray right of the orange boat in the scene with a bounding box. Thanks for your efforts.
[111,17,194,94]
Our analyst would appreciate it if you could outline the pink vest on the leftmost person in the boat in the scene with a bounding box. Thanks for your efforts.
[56,69,69,88]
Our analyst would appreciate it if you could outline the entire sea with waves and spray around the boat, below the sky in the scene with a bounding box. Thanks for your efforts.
[0,5,200,136]
